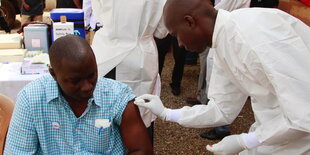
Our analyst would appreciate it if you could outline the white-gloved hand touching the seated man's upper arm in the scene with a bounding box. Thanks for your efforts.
[134,94,167,120]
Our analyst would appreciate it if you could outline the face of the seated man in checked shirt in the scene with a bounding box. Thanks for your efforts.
[54,55,98,101]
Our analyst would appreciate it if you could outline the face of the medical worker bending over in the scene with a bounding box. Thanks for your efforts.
[165,15,207,53]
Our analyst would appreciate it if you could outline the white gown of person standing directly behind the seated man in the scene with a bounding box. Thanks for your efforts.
[92,0,168,126]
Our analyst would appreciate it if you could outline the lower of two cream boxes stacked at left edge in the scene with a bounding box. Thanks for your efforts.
[0,49,27,62]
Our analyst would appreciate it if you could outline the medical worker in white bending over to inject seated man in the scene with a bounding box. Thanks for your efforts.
[135,0,310,155]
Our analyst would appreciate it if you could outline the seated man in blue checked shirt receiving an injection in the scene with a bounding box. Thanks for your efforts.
[5,35,153,154]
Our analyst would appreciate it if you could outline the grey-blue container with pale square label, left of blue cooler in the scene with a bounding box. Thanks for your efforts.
[24,24,50,53]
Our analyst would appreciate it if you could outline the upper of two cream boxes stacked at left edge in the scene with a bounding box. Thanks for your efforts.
[0,34,22,49]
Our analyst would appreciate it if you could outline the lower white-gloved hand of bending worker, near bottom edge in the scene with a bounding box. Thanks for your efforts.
[207,134,247,155]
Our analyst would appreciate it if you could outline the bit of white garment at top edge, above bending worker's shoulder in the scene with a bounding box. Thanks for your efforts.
[214,0,251,11]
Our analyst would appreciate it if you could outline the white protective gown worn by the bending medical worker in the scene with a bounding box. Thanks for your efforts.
[178,8,310,155]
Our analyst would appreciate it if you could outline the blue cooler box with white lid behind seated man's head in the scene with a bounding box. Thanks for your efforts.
[50,8,85,40]
